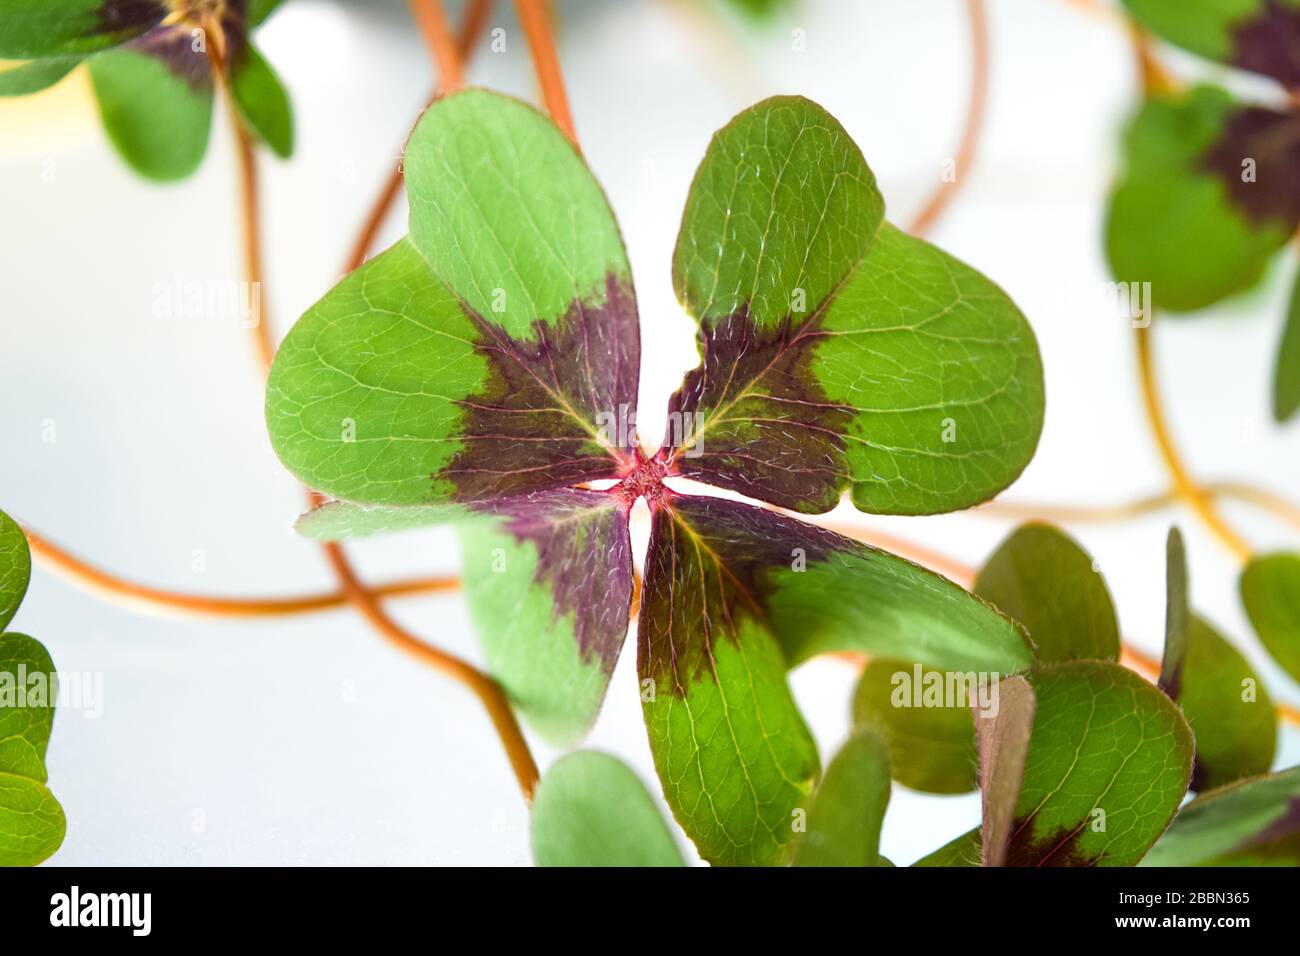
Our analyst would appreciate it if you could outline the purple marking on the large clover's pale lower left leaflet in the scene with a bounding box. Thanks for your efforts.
[475,488,632,674]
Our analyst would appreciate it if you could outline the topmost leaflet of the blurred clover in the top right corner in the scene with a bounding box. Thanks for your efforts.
[1125,0,1300,87]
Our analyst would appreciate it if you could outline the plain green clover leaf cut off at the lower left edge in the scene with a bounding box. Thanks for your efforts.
[0,511,68,866]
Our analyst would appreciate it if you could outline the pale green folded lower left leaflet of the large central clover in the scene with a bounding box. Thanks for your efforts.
[298,488,632,747]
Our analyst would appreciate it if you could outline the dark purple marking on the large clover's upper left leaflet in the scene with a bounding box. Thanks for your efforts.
[444,276,641,502]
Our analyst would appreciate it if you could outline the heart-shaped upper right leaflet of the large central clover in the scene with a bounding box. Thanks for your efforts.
[664,96,1043,514]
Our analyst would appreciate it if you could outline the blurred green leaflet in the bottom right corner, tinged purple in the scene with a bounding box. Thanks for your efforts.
[1141,767,1300,866]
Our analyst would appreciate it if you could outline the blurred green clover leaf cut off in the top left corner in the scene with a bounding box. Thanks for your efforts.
[0,0,294,181]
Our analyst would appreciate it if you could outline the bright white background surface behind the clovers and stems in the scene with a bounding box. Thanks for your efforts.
[0,0,1300,865]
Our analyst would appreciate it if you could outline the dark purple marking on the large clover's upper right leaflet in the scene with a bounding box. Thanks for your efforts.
[664,307,853,512]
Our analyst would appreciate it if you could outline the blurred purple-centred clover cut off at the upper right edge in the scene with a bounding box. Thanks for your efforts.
[1106,0,1300,423]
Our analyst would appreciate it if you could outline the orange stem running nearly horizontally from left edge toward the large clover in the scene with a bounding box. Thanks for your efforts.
[23,528,460,618]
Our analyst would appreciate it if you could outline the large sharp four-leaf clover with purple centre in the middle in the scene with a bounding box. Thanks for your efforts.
[267,90,1043,864]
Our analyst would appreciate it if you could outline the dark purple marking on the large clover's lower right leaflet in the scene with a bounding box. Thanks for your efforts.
[637,494,862,696]
